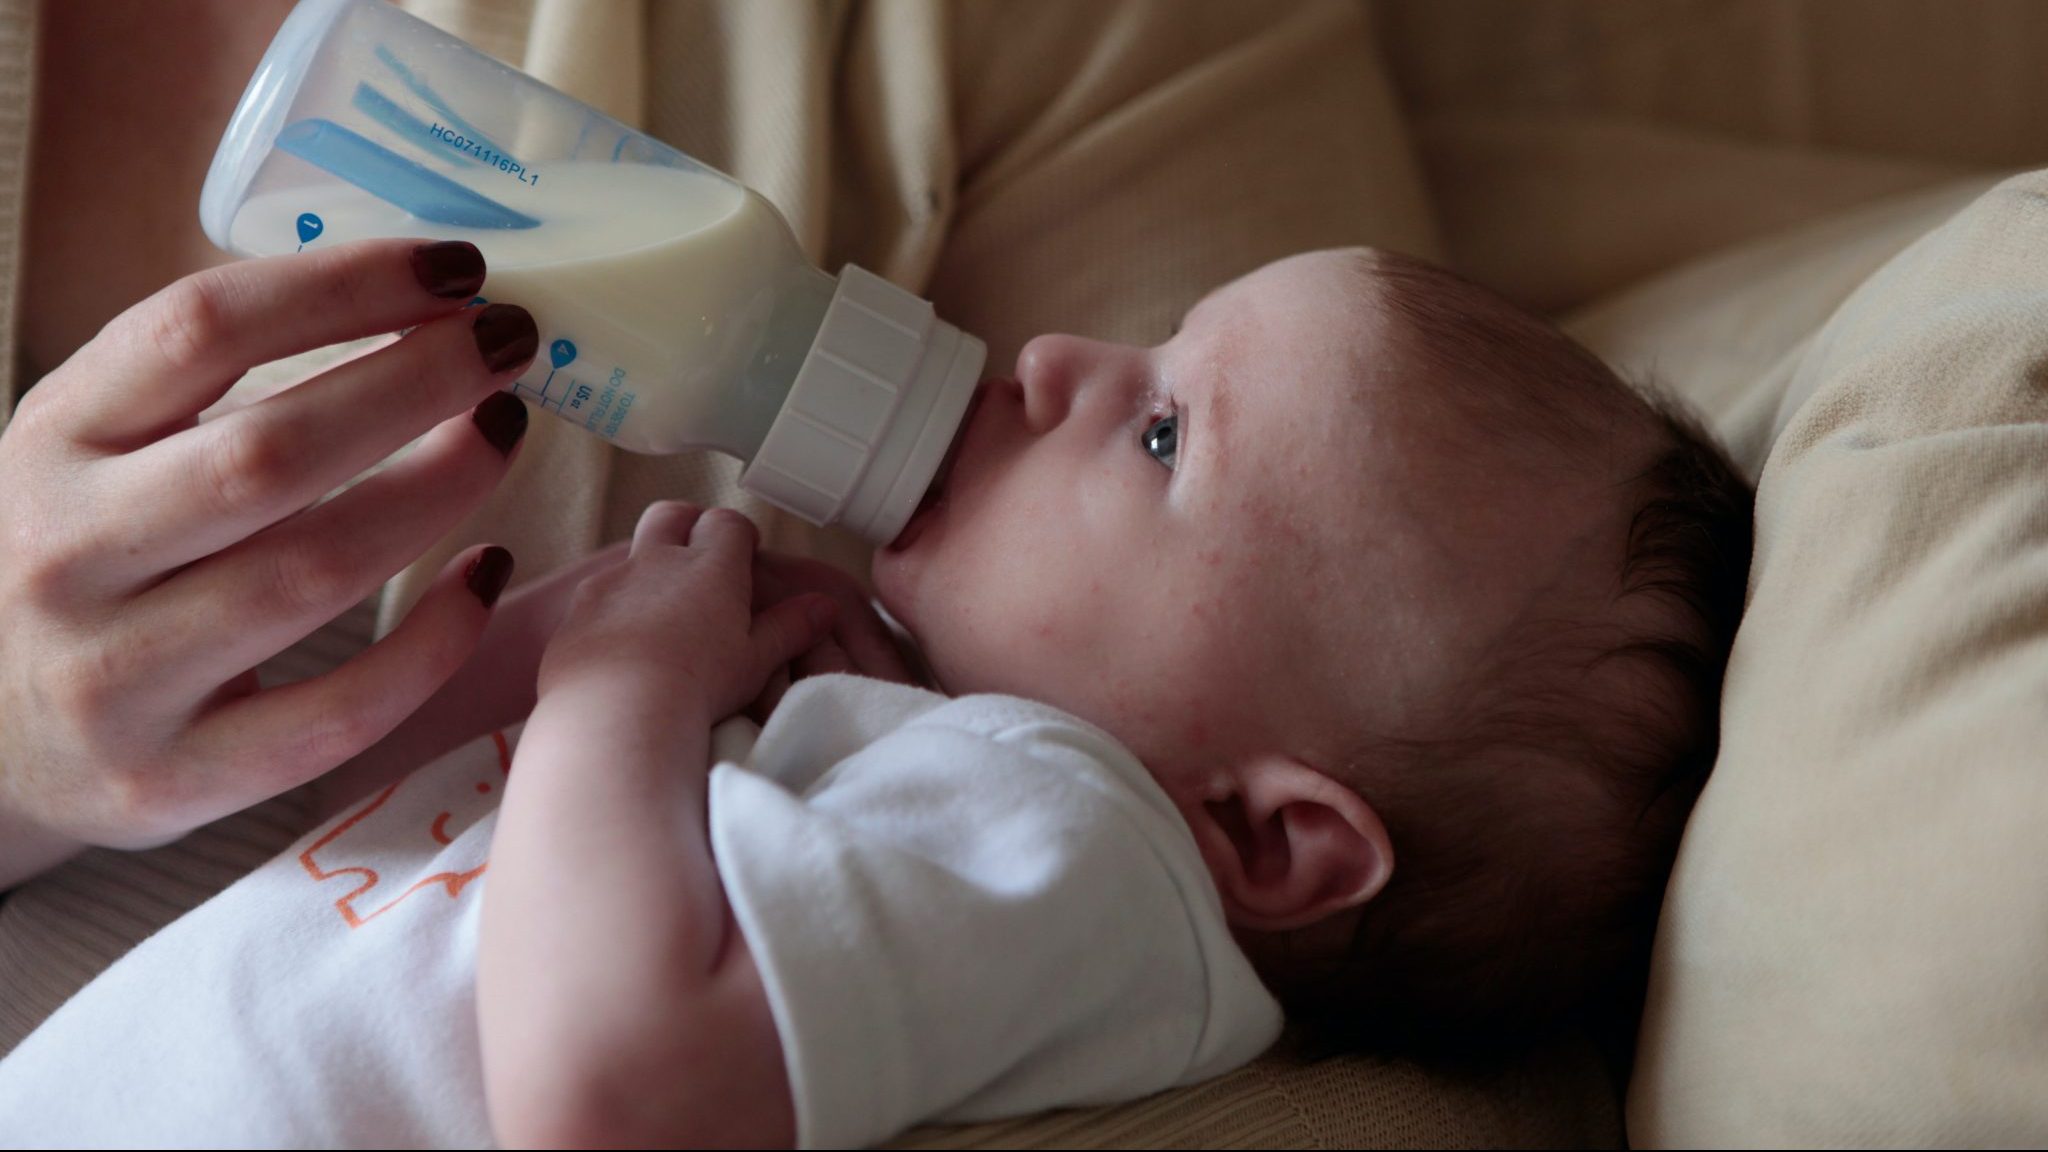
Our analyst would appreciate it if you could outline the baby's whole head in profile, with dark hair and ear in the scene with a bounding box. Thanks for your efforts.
[874,250,1751,1035]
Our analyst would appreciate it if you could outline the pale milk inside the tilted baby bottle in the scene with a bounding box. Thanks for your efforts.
[231,164,834,459]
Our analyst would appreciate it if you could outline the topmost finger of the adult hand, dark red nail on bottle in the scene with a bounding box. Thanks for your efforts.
[37,240,483,451]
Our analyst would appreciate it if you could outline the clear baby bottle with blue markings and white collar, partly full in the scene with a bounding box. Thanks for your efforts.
[199,0,985,543]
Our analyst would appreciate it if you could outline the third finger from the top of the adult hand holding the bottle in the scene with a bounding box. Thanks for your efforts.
[125,396,524,683]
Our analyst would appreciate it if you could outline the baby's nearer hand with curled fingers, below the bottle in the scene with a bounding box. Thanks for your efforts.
[539,502,838,726]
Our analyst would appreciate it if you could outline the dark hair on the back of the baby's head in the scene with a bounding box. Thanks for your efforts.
[1266,252,1755,1047]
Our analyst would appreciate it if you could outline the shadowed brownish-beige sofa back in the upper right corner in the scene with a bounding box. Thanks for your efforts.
[1372,0,2048,310]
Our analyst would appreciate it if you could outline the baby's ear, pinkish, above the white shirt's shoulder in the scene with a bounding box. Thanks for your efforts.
[1182,756,1395,933]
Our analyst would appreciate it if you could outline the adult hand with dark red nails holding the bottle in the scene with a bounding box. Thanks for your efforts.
[0,240,539,873]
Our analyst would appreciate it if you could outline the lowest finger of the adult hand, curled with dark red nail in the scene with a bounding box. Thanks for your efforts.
[186,547,512,820]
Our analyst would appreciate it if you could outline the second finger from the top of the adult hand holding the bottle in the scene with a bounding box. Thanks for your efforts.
[100,303,539,584]
